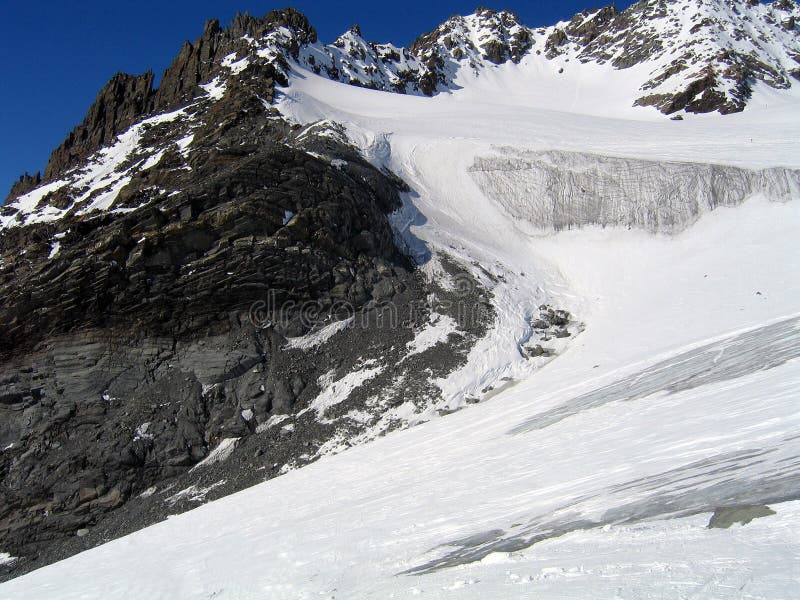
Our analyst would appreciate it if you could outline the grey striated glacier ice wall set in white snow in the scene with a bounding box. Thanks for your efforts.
[469,147,800,233]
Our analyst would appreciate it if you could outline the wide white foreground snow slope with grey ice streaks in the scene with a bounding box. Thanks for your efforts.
[0,182,800,598]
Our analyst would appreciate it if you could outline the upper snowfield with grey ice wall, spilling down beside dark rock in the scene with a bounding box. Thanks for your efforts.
[278,54,800,408]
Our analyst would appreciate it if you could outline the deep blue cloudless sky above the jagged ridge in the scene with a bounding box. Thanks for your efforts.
[0,0,631,196]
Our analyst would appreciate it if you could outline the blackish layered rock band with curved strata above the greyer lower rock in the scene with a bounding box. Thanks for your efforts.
[0,139,399,358]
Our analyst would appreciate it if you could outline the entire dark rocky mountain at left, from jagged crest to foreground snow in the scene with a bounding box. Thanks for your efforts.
[0,10,492,579]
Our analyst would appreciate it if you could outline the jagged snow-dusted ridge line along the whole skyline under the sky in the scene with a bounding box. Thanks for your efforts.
[6,0,800,202]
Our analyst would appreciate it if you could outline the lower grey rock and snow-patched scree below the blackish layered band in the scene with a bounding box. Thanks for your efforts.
[0,253,489,580]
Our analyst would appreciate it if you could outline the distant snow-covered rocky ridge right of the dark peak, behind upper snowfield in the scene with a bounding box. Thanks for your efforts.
[268,0,800,114]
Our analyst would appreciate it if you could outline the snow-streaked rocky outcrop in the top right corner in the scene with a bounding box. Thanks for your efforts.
[545,0,800,114]
